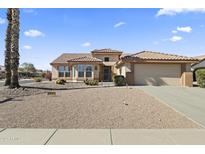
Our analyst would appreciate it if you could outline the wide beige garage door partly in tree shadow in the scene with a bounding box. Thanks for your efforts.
[134,64,181,86]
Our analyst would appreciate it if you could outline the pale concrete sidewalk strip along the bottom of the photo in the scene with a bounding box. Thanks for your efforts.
[0,129,205,145]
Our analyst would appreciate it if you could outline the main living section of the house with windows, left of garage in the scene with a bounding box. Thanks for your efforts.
[51,49,122,82]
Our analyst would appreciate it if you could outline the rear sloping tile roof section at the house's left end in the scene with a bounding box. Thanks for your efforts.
[51,53,91,64]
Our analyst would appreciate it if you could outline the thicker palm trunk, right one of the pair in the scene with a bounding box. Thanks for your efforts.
[10,8,20,88]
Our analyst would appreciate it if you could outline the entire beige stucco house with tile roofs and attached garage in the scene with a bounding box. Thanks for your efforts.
[51,49,198,86]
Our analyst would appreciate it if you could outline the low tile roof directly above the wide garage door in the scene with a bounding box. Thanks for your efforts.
[122,51,198,61]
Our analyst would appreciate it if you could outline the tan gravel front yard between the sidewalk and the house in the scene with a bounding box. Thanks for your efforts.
[0,87,200,129]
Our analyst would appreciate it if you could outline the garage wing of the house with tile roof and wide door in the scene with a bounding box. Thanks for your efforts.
[117,51,198,87]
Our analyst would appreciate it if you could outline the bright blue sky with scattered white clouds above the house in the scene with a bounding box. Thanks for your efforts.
[0,9,205,69]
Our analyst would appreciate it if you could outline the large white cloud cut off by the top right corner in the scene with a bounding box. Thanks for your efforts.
[156,8,205,17]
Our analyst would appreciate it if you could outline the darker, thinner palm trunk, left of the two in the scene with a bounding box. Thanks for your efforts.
[4,9,12,86]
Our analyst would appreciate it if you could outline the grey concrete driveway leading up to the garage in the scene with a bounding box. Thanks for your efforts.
[137,86,205,127]
